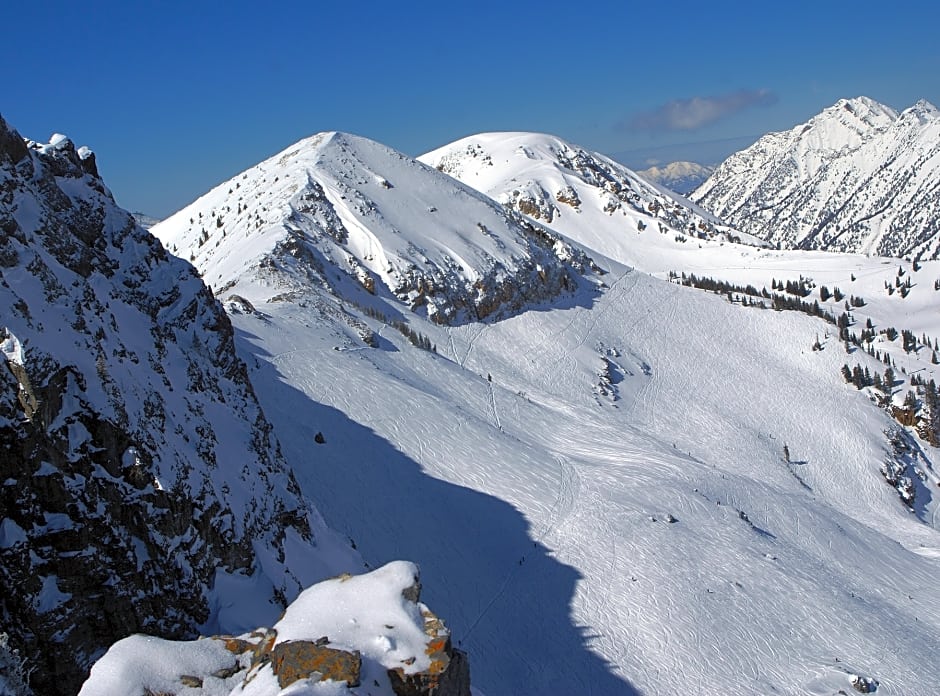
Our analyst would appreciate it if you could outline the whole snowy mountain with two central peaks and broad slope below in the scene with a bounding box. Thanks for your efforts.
[154,128,940,696]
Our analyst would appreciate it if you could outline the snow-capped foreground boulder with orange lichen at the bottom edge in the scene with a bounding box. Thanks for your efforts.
[80,561,470,696]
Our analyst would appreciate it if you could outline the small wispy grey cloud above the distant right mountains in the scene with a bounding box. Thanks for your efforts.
[617,89,777,133]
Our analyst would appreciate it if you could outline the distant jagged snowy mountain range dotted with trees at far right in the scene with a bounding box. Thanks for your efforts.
[691,97,940,259]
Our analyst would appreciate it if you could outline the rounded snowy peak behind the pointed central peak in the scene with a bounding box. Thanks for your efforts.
[419,133,761,265]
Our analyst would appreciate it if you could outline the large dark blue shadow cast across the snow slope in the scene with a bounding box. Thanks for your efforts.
[237,331,639,696]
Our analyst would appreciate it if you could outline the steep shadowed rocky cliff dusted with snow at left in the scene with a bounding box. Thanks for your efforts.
[0,120,353,694]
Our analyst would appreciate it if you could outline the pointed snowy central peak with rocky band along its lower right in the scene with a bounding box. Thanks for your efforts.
[153,133,591,323]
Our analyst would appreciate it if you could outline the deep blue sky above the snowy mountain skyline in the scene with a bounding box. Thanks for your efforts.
[0,0,940,217]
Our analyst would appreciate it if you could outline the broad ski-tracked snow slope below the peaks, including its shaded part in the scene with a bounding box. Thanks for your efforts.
[155,133,940,696]
